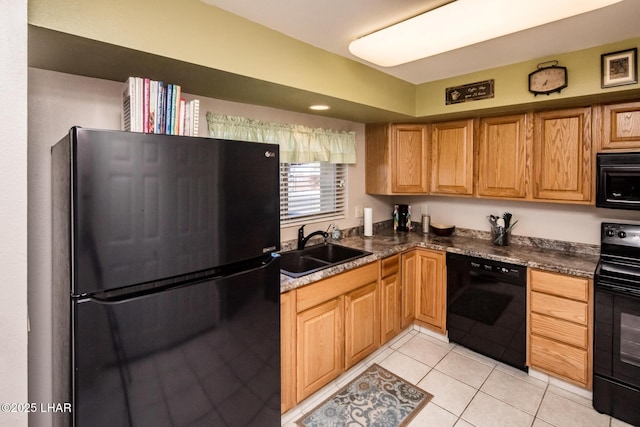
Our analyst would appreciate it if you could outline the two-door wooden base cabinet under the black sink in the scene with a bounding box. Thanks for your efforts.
[289,262,380,403]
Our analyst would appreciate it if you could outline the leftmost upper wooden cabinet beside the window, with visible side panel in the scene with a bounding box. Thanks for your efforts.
[365,124,429,194]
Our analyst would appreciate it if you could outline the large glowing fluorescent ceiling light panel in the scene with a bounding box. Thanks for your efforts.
[349,0,622,67]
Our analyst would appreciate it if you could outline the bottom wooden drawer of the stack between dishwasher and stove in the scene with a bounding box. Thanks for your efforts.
[529,335,589,385]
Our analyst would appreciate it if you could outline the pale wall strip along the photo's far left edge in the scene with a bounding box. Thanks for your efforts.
[0,0,29,426]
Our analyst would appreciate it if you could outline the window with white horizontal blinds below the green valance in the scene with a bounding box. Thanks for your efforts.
[280,162,347,225]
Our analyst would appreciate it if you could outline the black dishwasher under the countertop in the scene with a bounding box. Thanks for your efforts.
[447,253,527,371]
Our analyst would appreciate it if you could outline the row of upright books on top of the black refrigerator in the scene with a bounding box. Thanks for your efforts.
[122,77,200,136]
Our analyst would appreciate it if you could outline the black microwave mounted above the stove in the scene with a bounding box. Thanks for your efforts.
[596,153,640,210]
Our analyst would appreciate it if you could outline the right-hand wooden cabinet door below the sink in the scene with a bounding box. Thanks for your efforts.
[344,282,380,369]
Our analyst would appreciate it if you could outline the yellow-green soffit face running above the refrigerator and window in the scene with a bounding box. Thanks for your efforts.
[29,0,415,114]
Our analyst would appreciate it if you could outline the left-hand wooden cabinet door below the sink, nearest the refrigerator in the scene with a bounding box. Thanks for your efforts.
[296,297,344,402]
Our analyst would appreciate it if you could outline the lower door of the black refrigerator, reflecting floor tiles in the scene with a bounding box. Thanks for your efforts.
[72,260,280,427]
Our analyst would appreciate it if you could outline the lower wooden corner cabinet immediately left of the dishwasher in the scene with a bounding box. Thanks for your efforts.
[402,249,446,334]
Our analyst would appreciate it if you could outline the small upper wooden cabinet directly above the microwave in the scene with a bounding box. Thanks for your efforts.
[601,102,640,150]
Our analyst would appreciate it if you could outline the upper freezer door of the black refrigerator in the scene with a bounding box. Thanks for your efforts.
[71,128,280,295]
